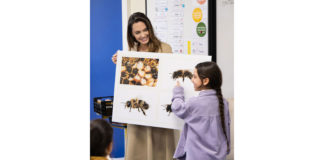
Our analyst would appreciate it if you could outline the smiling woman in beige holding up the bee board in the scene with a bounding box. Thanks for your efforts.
[112,12,179,160]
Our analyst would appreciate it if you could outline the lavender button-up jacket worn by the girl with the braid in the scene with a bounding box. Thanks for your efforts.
[171,87,231,160]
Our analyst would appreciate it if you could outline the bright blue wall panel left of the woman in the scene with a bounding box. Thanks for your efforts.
[90,0,124,157]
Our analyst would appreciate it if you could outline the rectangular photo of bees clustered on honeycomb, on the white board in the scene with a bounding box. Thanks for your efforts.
[120,57,159,87]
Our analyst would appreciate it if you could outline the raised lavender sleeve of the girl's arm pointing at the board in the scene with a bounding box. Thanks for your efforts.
[171,86,189,119]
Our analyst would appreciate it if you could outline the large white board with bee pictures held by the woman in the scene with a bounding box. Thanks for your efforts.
[112,51,211,129]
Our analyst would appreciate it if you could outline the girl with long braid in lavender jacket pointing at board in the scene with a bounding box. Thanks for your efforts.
[171,62,231,160]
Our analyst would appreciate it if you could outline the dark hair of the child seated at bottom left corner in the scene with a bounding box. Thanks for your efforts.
[90,119,113,156]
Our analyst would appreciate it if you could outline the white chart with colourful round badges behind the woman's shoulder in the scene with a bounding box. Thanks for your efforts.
[146,0,208,55]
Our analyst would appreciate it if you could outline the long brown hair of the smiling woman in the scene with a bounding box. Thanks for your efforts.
[127,12,161,52]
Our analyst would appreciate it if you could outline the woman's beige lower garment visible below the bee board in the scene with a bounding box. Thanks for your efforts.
[125,124,180,160]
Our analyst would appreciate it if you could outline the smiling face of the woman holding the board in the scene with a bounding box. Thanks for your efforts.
[132,21,150,45]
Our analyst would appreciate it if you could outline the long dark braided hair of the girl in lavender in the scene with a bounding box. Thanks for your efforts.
[195,62,229,150]
